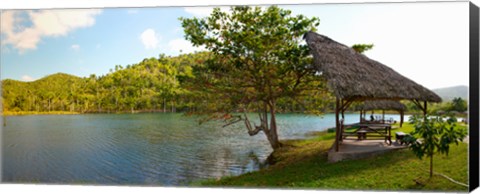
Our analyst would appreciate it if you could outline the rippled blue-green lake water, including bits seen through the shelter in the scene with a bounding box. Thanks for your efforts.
[2,113,399,186]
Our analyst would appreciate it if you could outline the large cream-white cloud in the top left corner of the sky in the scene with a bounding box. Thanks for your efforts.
[1,10,101,53]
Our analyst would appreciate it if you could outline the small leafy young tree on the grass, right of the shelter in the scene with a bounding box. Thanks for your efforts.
[405,115,466,178]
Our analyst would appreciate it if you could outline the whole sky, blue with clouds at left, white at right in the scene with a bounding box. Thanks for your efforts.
[1,2,469,89]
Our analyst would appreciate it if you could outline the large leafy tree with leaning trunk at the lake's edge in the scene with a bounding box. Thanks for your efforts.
[180,6,323,149]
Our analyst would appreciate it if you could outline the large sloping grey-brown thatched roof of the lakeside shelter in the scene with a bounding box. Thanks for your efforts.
[304,32,441,102]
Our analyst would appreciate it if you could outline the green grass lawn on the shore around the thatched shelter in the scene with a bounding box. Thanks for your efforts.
[196,123,468,192]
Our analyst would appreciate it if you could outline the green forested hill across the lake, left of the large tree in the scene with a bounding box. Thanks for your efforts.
[2,53,206,113]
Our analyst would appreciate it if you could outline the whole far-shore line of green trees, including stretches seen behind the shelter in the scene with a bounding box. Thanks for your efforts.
[1,52,468,114]
